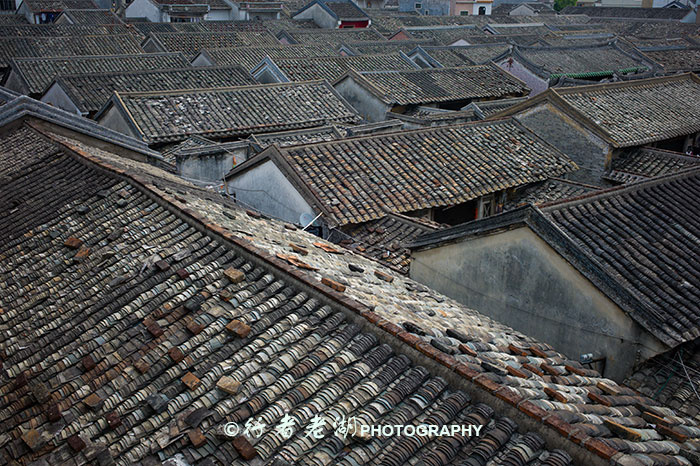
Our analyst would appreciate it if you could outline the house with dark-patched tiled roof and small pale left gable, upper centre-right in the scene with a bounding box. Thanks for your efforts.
[333,64,529,121]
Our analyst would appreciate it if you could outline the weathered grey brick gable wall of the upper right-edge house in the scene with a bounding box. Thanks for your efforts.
[516,104,611,186]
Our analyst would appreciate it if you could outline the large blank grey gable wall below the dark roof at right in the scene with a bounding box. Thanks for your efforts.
[410,227,664,382]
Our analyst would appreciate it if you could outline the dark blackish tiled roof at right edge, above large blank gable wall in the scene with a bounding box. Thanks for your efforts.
[544,169,700,347]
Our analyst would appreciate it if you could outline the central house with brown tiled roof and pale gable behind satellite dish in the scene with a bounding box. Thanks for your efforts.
[226,119,576,229]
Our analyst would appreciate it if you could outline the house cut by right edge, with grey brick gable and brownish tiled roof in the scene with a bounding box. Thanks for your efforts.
[491,73,700,186]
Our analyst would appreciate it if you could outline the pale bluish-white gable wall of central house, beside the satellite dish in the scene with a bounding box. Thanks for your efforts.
[227,160,317,223]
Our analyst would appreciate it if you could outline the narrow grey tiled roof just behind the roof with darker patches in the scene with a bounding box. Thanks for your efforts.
[262,53,418,82]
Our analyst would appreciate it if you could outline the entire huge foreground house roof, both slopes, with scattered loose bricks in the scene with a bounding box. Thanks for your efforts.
[0,92,698,466]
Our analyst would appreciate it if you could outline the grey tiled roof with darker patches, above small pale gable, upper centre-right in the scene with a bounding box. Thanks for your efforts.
[341,65,528,105]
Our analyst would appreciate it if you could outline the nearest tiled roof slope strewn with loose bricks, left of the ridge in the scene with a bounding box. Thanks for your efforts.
[0,120,588,466]
